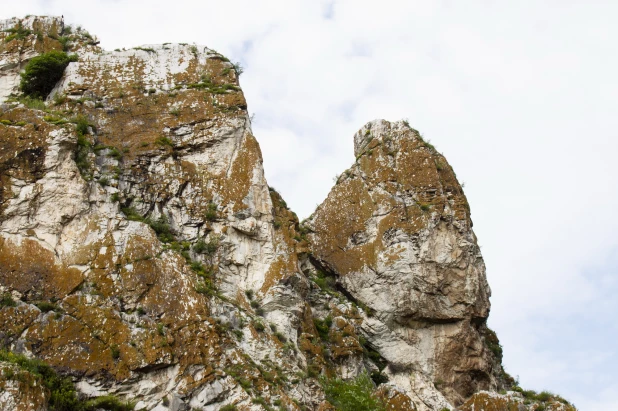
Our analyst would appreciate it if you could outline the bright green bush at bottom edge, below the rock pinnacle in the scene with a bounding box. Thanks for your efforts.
[320,373,386,411]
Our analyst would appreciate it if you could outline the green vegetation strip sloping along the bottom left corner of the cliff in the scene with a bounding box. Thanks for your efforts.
[0,350,135,411]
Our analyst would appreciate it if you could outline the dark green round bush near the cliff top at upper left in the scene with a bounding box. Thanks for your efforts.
[19,50,77,98]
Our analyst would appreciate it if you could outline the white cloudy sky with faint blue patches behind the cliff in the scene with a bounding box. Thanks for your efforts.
[0,0,618,411]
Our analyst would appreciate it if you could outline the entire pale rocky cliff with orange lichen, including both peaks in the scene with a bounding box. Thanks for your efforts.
[0,17,570,411]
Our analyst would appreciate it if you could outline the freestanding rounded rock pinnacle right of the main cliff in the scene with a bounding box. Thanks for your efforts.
[307,120,499,409]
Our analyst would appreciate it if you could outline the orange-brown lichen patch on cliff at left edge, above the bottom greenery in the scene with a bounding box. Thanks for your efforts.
[0,237,83,300]
